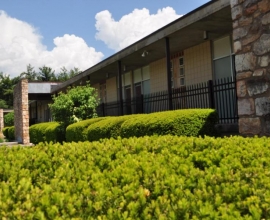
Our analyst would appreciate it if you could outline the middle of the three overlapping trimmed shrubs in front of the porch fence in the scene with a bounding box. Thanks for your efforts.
[87,115,138,141]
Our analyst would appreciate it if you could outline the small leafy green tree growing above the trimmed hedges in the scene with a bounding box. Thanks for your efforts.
[49,84,99,127]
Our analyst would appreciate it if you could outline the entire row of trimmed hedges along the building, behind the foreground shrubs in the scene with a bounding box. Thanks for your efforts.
[30,109,218,143]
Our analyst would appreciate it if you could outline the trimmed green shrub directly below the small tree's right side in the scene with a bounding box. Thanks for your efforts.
[66,117,105,142]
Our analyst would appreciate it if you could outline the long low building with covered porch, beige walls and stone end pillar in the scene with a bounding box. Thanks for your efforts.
[12,0,270,144]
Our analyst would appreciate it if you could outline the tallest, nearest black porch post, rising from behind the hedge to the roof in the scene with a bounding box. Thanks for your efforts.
[165,37,173,110]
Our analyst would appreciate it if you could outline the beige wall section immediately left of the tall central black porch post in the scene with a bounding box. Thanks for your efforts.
[150,58,167,93]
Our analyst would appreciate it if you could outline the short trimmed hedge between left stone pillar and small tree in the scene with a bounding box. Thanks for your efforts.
[29,122,63,144]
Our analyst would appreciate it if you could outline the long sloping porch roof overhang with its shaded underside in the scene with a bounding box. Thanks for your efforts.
[52,0,232,93]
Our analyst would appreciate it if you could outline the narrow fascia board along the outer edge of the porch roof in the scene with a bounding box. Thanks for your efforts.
[52,0,230,93]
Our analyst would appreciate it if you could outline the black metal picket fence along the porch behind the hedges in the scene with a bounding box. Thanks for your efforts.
[97,78,238,124]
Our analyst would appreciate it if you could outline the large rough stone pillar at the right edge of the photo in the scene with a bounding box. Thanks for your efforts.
[231,0,270,136]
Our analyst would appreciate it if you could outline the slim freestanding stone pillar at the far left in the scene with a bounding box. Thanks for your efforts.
[13,79,30,144]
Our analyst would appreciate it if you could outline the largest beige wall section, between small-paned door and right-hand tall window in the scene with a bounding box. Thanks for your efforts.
[184,41,213,85]
